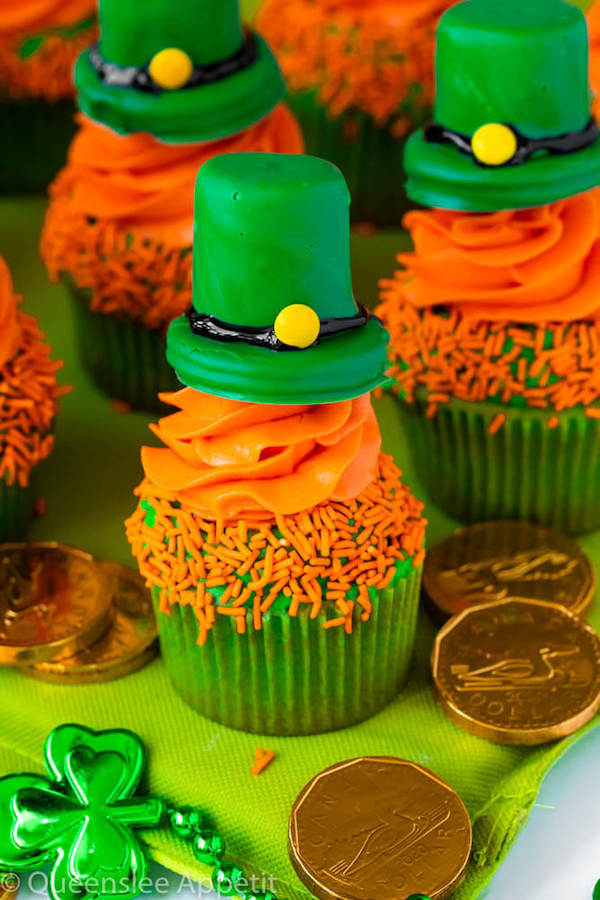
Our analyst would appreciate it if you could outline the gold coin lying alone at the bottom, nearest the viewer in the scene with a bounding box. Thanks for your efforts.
[289,756,471,900]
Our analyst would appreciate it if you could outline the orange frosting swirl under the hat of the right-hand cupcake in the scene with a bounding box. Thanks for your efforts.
[394,189,600,323]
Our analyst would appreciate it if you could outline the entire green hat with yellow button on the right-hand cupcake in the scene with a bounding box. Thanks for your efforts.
[405,0,600,212]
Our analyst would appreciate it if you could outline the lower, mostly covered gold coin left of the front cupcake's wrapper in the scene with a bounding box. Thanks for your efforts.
[26,563,158,684]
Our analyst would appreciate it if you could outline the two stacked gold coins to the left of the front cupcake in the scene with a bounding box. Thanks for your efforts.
[0,542,157,684]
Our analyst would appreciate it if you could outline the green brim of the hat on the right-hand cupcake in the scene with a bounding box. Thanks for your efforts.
[404,131,600,212]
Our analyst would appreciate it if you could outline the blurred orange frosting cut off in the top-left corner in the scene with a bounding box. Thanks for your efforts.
[0,0,96,35]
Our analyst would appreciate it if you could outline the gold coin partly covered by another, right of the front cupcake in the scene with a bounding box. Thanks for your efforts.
[423,520,596,619]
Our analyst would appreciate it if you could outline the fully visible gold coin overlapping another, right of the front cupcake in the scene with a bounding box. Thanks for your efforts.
[432,598,600,745]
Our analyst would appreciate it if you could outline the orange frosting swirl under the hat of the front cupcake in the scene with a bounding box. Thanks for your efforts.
[142,388,381,519]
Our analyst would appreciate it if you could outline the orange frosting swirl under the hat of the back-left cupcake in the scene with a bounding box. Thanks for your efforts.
[45,104,304,243]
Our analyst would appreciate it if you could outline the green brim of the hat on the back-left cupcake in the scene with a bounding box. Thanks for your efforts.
[75,35,285,144]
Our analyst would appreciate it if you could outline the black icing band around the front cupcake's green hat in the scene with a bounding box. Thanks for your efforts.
[186,305,370,351]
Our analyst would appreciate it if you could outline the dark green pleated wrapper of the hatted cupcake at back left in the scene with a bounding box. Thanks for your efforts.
[68,282,181,413]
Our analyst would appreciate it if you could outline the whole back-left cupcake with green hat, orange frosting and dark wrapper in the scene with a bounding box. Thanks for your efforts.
[41,0,304,409]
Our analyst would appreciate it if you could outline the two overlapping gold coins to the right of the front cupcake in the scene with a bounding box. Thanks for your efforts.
[423,521,600,745]
